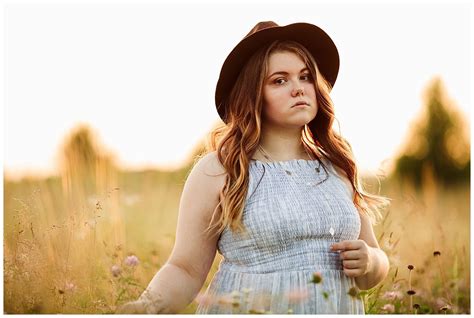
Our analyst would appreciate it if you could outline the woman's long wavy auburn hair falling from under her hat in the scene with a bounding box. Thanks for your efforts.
[200,41,388,238]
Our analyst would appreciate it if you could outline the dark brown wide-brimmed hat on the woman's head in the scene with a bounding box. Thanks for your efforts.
[215,21,339,121]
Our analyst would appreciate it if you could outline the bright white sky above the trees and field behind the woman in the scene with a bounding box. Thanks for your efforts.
[2,1,472,179]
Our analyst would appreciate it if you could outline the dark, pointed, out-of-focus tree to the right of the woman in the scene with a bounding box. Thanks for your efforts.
[394,78,470,187]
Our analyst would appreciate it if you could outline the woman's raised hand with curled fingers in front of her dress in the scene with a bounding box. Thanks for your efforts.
[331,240,372,277]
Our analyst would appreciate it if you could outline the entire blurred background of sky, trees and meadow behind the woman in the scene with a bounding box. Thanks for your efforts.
[3,1,472,313]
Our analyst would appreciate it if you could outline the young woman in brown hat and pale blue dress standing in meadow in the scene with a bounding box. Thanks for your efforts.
[115,21,389,314]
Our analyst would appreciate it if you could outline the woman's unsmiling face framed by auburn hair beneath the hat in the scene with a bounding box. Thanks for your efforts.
[262,51,318,128]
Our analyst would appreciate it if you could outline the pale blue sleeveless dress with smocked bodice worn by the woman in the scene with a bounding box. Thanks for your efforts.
[196,159,365,314]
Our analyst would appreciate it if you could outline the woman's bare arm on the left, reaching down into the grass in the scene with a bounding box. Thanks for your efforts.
[117,152,225,313]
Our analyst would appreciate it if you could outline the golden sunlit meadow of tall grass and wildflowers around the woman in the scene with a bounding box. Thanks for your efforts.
[4,165,470,314]
